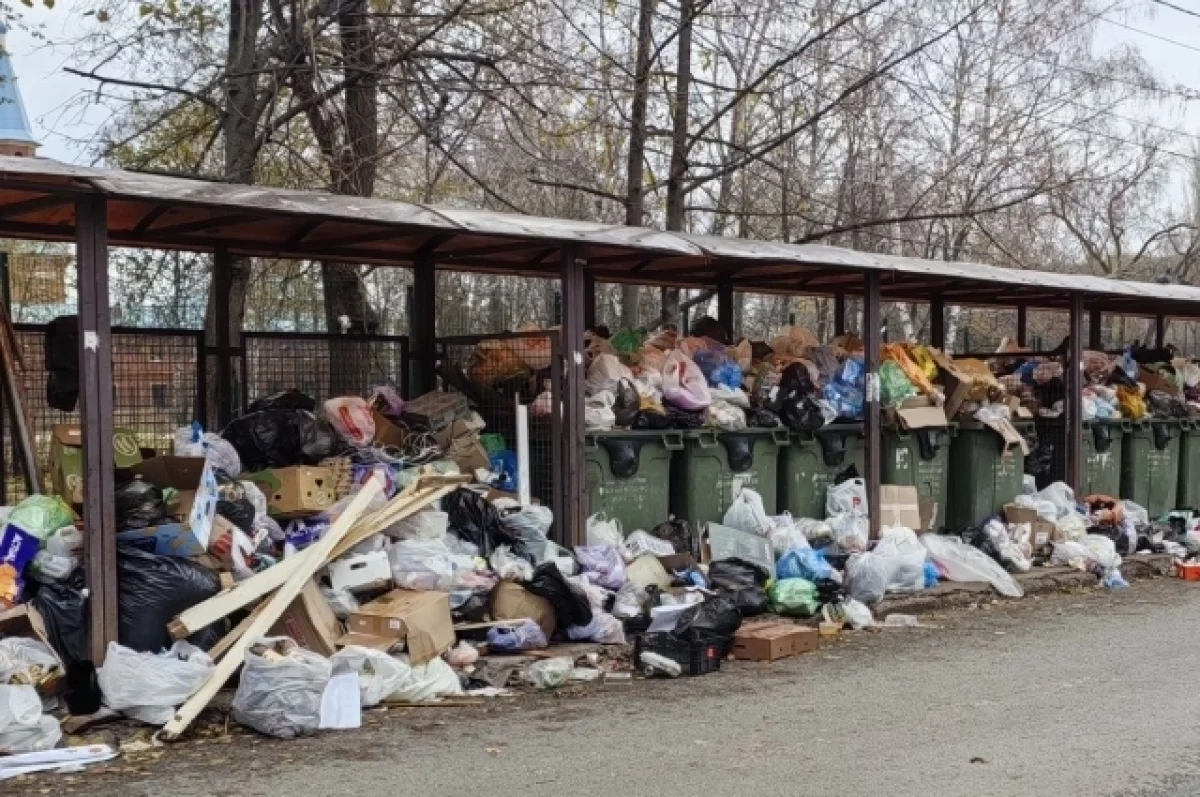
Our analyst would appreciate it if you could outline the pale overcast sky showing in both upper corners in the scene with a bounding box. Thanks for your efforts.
[8,0,1200,170]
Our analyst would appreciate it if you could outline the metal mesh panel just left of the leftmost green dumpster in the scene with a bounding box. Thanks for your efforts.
[437,334,562,511]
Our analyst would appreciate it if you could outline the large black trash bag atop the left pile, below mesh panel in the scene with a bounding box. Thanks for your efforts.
[221,409,338,471]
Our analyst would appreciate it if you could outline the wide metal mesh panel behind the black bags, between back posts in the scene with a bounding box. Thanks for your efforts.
[241,332,408,407]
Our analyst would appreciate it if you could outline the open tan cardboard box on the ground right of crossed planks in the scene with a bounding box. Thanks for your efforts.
[346,589,455,664]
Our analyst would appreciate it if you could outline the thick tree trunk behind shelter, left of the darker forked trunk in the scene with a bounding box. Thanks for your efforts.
[200,0,263,426]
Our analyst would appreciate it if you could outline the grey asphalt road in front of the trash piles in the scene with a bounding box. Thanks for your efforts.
[14,580,1200,797]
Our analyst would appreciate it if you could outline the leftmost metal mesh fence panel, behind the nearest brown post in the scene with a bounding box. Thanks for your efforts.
[4,325,203,502]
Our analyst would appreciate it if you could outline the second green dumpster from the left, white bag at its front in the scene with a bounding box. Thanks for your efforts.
[671,429,790,528]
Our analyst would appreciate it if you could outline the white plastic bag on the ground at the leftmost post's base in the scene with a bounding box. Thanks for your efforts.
[96,641,214,725]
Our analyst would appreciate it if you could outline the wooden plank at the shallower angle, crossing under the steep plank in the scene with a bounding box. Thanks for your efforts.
[168,484,457,640]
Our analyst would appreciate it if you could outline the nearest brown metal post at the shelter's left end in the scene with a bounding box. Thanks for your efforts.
[76,194,117,667]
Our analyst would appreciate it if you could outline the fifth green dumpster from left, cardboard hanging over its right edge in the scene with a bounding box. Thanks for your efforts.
[946,420,1033,531]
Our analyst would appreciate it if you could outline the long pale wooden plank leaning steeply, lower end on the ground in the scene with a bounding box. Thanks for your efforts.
[162,478,382,741]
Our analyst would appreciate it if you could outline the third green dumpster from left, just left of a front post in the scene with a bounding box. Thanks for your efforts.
[779,423,866,520]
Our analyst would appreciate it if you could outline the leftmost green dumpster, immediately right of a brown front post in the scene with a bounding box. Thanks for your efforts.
[584,431,683,534]
